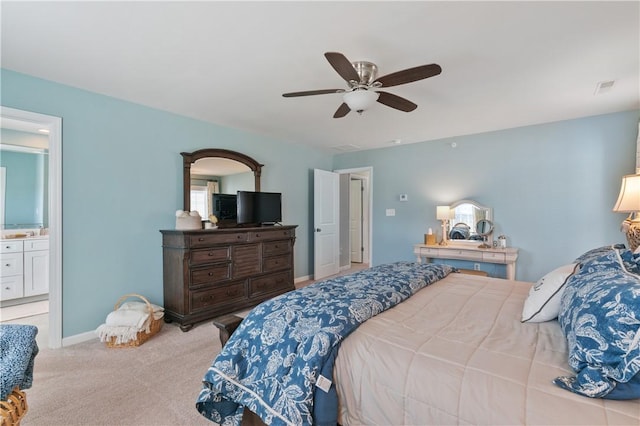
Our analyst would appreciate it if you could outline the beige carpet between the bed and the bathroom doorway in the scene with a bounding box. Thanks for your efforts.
[22,322,220,426]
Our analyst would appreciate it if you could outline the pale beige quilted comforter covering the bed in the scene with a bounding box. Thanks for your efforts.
[334,274,640,425]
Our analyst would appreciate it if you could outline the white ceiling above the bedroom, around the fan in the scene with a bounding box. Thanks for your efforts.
[1,0,640,152]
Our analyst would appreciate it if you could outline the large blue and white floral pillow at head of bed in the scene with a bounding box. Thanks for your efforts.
[554,250,640,399]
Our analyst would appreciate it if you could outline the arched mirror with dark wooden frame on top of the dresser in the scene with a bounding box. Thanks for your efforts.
[180,148,263,227]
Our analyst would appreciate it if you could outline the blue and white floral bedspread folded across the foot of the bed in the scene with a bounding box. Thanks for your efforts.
[196,262,452,425]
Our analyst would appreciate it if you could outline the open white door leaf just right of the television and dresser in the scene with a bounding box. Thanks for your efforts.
[313,169,340,280]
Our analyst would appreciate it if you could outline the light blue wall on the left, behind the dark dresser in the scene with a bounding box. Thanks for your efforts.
[0,69,332,337]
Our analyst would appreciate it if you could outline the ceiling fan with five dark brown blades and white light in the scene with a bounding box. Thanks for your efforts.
[282,52,442,118]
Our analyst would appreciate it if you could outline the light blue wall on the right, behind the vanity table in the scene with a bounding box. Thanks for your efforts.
[334,111,640,281]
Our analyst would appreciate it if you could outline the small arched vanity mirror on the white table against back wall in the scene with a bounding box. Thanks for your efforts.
[449,200,493,244]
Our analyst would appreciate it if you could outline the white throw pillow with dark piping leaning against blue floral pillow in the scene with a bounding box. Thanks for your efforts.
[522,263,578,322]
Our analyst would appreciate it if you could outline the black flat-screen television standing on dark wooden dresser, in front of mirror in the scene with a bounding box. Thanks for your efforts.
[236,191,282,225]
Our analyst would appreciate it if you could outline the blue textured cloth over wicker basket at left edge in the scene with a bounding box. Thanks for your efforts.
[0,324,38,402]
